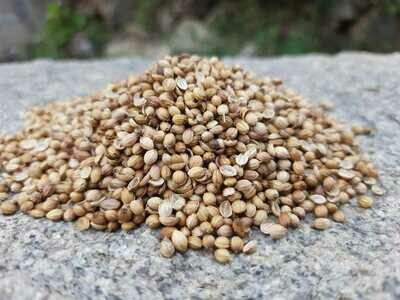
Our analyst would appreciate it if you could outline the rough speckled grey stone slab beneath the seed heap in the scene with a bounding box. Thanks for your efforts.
[0,53,400,299]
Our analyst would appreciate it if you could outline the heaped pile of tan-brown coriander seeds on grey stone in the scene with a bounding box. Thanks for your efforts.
[0,54,383,263]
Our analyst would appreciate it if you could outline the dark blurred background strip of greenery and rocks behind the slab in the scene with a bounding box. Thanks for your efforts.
[0,0,400,61]
